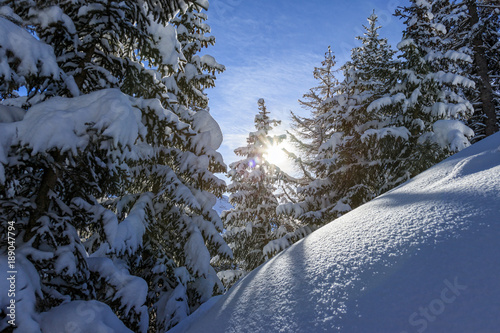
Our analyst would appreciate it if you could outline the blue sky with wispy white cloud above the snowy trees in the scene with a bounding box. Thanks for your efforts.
[207,0,408,172]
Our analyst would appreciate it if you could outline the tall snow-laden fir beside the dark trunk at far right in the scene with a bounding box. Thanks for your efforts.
[368,0,474,185]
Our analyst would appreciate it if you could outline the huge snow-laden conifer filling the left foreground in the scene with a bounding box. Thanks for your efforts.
[0,0,230,332]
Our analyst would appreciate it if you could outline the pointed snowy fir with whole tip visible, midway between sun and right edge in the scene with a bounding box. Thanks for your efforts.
[320,12,400,210]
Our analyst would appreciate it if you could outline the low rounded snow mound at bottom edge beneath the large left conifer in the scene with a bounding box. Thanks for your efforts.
[39,301,132,333]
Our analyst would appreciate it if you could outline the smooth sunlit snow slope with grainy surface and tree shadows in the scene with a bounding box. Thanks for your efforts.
[171,133,500,333]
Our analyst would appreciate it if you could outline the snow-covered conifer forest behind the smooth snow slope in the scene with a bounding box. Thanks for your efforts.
[0,0,500,333]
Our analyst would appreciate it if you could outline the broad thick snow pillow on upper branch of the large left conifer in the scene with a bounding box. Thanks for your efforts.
[17,89,145,154]
